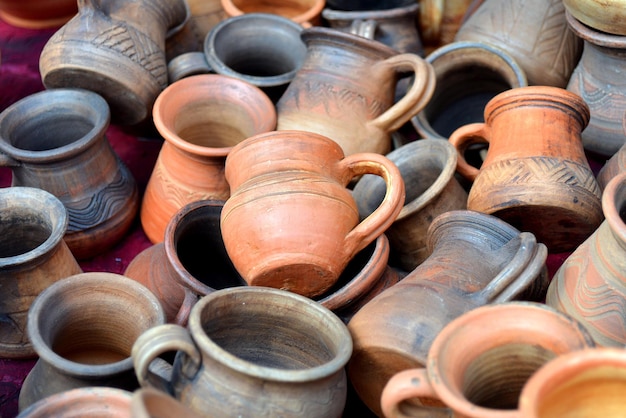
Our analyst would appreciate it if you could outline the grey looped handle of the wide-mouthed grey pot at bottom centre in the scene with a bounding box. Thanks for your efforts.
[131,324,202,396]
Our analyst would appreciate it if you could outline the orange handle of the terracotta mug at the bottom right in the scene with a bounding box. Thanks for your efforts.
[380,369,451,418]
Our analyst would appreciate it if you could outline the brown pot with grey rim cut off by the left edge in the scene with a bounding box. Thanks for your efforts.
[0,186,82,358]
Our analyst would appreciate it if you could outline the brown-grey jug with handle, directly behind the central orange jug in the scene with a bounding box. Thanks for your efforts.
[276,27,435,155]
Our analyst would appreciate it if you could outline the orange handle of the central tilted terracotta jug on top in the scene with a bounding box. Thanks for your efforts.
[339,152,405,259]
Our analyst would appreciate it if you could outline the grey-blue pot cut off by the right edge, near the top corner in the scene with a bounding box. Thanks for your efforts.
[566,13,626,158]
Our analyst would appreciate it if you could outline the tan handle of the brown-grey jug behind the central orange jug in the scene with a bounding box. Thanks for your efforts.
[370,53,436,132]
